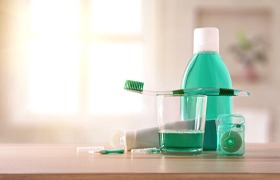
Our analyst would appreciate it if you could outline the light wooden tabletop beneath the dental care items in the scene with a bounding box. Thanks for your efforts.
[0,144,280,180]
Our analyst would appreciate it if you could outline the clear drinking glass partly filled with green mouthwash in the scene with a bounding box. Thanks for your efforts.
[157,95,207,155]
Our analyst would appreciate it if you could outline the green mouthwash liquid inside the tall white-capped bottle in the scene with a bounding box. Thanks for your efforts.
[181,52,232,150]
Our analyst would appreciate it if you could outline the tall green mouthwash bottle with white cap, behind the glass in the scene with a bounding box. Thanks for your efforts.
[181,28,232,150]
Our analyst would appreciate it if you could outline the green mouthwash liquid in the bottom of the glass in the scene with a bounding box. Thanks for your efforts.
[159,130,204,155]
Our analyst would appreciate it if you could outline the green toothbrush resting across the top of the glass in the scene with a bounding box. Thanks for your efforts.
[124,80,250,96]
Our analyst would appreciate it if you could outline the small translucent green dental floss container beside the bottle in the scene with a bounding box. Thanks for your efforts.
[216,114,245,156]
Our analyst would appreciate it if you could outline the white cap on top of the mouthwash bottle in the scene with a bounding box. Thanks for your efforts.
[193,27,219,54]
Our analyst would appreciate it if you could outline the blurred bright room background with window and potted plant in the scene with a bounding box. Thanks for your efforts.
[0,0,280,143]
